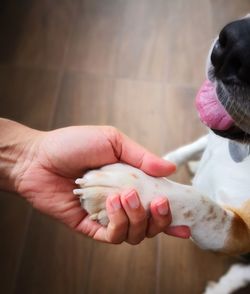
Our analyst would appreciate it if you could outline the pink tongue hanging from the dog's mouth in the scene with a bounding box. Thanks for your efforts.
[196,80,234,131]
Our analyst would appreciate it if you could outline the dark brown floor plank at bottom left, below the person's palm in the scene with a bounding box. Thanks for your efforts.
[14,211,94,294]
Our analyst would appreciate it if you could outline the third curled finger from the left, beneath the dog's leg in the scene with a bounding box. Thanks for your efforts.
[147,198,172,238]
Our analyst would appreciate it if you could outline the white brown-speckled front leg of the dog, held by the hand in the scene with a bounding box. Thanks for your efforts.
[74,164,242,251]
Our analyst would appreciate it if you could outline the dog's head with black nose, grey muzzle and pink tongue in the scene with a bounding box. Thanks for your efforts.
[196,15,250,144]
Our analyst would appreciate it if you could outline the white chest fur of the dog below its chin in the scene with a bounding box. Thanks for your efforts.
[193,132,250,208]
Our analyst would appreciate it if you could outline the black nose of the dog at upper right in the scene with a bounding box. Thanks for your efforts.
[211,18,250,83]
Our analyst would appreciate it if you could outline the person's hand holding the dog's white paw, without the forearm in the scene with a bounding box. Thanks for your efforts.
[5,122,189,244]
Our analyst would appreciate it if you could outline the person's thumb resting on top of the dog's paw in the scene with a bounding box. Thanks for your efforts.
[103,127,176,177]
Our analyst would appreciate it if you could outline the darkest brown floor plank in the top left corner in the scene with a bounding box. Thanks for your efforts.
[0,0,78,68]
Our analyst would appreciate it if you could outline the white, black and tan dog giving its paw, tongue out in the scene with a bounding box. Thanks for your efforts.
[74,16,250,293]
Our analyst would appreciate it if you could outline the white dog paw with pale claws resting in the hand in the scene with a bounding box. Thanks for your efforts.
[73,163,151,226]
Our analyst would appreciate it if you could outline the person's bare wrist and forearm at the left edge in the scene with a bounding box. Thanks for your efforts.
[0,118,41,191]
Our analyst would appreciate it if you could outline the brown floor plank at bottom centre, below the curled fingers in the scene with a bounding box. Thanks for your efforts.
[86,239,157,294]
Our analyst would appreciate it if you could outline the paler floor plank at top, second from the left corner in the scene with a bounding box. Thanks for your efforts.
[66,0,127,77]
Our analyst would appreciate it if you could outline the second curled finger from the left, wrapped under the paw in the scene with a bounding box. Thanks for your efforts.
[121,190,147,245]
